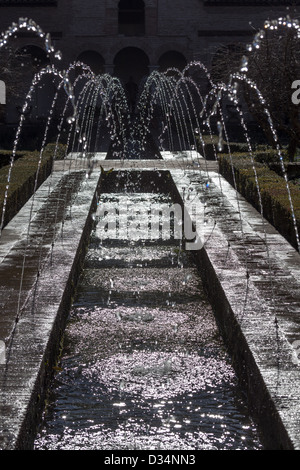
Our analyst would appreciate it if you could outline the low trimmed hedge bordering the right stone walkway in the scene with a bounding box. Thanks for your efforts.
[218,153,300,249]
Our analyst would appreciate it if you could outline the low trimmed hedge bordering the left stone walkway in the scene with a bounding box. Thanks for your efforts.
[0,144,64,227]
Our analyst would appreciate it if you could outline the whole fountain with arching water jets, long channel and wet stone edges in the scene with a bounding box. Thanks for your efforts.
[0,18,300,450]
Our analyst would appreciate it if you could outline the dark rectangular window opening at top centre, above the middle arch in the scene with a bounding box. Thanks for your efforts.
[118,0,145,36]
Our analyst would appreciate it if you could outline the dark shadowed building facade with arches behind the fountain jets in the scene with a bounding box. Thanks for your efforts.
[0,0,300,125]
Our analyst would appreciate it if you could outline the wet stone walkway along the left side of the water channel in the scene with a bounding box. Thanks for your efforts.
[0,168,99,450]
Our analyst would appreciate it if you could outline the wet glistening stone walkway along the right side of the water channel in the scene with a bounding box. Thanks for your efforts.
[171,170,300,449]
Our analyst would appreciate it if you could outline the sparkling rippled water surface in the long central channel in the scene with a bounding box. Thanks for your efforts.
[35,195,262,450]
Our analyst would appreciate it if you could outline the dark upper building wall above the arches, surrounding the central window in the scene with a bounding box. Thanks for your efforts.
[0,0,292,71]
